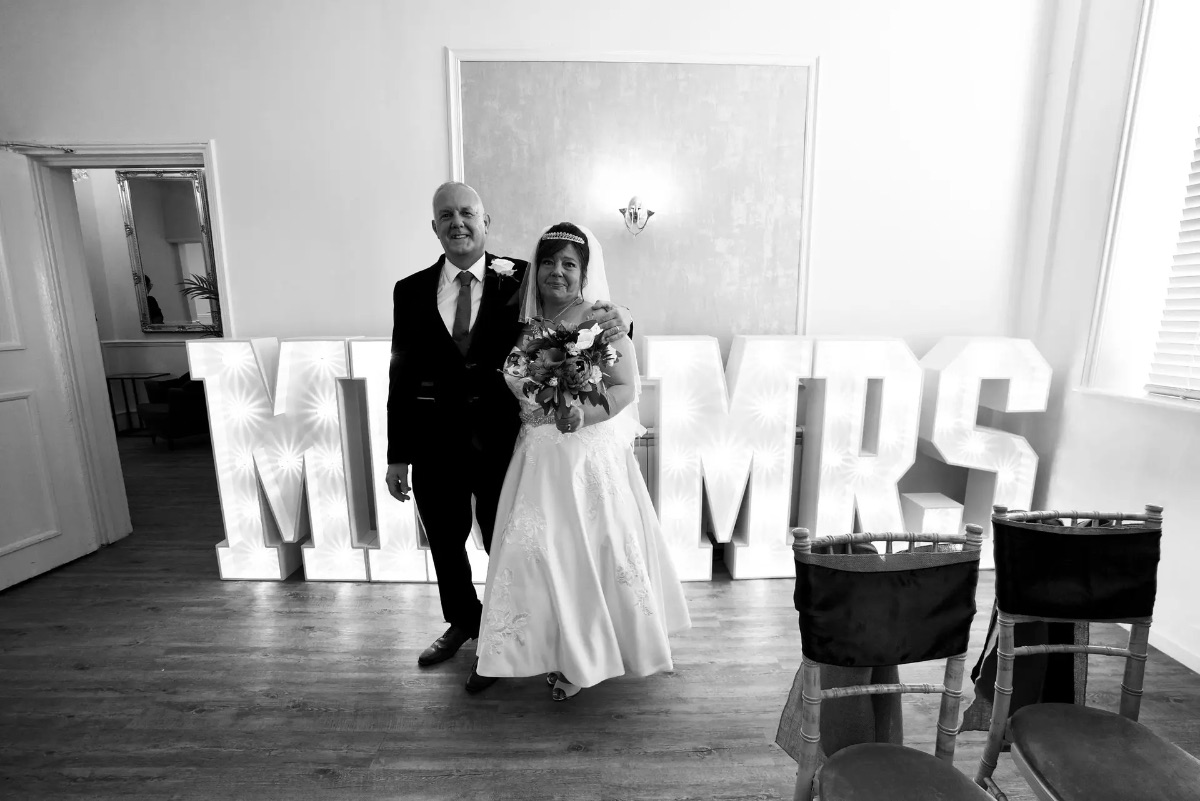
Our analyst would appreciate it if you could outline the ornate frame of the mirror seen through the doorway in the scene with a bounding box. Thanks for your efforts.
[116,167,224,337]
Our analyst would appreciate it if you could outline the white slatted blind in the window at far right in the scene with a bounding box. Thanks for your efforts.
[1146,128,1200,401]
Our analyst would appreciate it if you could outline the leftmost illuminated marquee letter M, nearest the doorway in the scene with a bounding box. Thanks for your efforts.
[187,337,367,582]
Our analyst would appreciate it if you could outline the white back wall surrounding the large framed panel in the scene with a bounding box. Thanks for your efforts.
[0,0,1048,354]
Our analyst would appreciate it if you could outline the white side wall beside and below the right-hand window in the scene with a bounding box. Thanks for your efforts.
[1021,0,1200,681]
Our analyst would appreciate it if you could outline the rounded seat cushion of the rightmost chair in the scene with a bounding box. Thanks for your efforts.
[1008,704,1200,801]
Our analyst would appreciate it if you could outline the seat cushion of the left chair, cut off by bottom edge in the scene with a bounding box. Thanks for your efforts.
[820,742,991,801]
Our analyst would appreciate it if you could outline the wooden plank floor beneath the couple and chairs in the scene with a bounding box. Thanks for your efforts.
[0,439,1200,801]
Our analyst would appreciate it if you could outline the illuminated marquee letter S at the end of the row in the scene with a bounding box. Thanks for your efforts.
[920,337,1050,567]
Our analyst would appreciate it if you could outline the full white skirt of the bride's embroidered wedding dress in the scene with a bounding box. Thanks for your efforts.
[478,366,691,687]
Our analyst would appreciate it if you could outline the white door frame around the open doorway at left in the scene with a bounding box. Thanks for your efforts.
[8,140,238,546]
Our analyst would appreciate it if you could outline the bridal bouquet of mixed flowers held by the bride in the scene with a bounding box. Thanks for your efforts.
[504,318,620,414]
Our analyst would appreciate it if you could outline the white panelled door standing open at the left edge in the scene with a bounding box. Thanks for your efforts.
[0,151,98,589]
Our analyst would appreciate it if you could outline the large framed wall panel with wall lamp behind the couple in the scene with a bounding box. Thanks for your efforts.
[448,50,816,354]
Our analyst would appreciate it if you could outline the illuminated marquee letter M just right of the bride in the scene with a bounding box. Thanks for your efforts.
[646,337,812,580]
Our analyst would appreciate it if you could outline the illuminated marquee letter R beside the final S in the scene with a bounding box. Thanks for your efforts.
[800,339,920,536]
